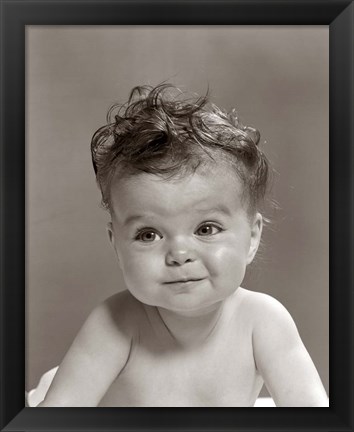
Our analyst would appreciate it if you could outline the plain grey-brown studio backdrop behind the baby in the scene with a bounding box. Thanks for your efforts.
[26,26,329,391]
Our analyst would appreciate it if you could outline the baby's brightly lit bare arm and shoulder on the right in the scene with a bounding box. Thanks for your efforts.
[240,290,328,407]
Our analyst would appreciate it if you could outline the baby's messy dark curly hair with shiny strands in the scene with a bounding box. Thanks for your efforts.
[91,84,269,213]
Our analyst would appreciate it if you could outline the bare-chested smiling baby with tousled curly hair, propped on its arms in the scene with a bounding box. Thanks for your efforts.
[39,84,328,407]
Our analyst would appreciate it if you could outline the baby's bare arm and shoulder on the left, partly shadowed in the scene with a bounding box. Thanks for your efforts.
[41,292,142,407]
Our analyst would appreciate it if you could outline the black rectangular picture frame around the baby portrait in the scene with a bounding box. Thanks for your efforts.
[0,0,354,432]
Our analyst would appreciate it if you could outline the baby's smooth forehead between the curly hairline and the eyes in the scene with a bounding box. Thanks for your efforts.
[111,161,250,220]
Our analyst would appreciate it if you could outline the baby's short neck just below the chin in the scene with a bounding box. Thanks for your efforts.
[157,300,231,347]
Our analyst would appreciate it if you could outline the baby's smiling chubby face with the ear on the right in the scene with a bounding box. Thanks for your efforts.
[108,164,262,313]
